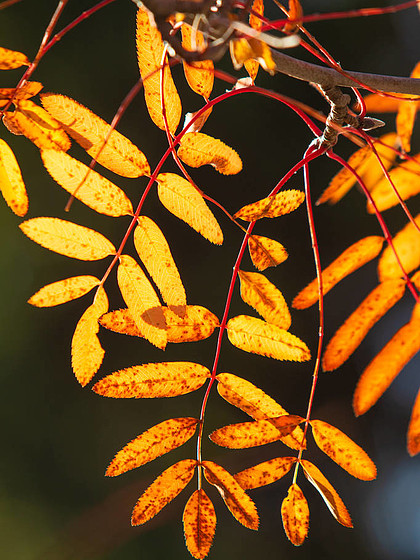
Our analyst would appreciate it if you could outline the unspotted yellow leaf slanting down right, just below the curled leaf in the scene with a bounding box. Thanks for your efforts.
[156,173,223,245]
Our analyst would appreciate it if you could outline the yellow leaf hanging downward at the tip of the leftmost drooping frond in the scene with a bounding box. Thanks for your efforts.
[71,287,108,387]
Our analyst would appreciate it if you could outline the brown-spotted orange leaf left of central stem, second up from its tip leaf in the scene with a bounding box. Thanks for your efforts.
[105,418,198,476]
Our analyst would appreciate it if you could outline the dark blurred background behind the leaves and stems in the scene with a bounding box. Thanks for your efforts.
[0,0,420,560]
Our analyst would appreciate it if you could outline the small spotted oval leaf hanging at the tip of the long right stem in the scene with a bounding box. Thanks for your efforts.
[281,484,309,546]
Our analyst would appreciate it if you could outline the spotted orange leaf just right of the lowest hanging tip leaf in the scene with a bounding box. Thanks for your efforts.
[202,461,259,531]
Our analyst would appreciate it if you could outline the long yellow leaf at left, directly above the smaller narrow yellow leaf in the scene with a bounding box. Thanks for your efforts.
[19,218,116,261]
